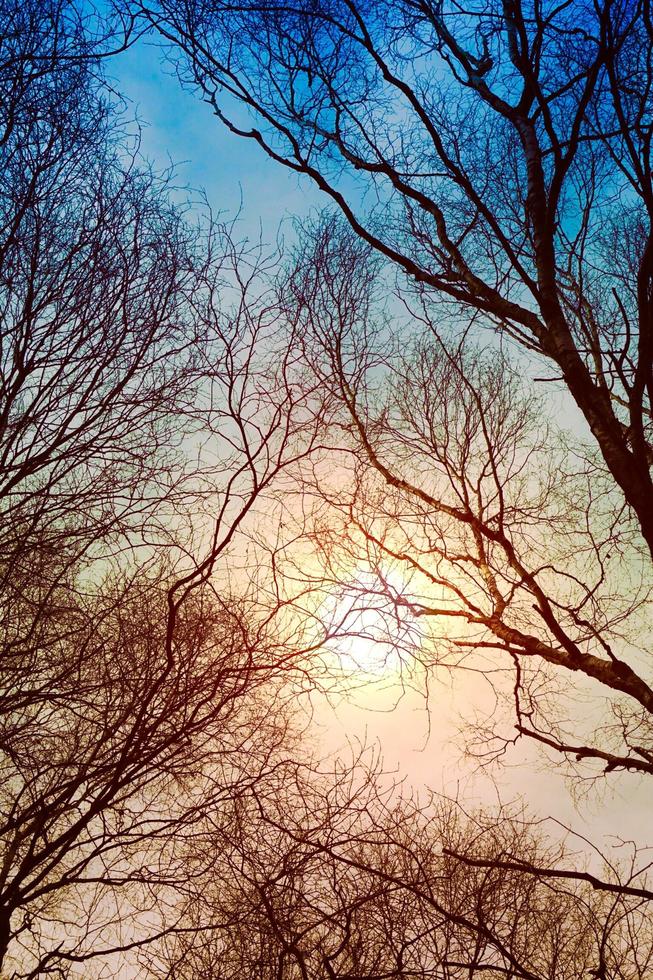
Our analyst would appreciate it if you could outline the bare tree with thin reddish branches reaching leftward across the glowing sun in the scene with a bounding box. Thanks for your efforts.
[284,222,653,775]
